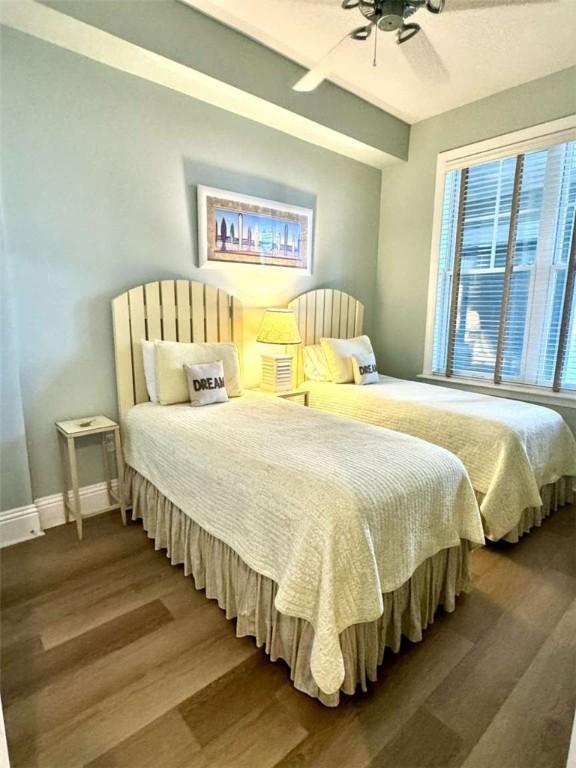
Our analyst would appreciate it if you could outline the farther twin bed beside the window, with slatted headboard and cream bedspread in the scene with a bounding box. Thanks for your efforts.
[289,290,576,543]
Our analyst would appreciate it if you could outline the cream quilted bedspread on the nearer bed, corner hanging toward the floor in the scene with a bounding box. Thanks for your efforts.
[125,392,483,693]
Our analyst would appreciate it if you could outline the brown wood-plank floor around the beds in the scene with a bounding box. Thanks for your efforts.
[1,507,576,768]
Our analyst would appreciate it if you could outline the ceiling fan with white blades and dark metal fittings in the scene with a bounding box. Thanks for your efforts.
[292,0,554,92]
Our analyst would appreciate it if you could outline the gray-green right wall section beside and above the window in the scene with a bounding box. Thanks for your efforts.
[376,68,576,432]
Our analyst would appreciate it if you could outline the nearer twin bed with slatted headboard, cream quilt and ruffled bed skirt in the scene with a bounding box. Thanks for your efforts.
[113,281,568,706]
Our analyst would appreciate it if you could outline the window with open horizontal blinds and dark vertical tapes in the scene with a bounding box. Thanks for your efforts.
[428,134,576,391]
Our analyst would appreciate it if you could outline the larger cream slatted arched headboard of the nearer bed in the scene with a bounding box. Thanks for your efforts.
[112,280,242,422]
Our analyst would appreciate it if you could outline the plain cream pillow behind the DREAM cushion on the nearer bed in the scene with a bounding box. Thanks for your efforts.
[154,341,242,405]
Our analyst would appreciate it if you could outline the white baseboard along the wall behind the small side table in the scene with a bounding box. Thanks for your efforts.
[0,481,118,547]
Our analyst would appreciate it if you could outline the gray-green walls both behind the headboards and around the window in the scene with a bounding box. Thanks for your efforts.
[0,30,576,509]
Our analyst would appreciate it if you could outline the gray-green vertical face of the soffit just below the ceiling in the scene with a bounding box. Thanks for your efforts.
[41,0,410,159]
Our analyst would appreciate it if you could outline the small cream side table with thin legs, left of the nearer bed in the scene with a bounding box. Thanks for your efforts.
[56,416,126,540]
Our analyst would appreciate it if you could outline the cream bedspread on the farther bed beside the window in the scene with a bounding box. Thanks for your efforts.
[302,376,576,540]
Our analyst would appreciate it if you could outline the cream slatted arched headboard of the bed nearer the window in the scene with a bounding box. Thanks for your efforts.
[288,288,364,384]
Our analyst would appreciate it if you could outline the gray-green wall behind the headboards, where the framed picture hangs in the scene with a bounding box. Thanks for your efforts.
[1,30,380,498]
